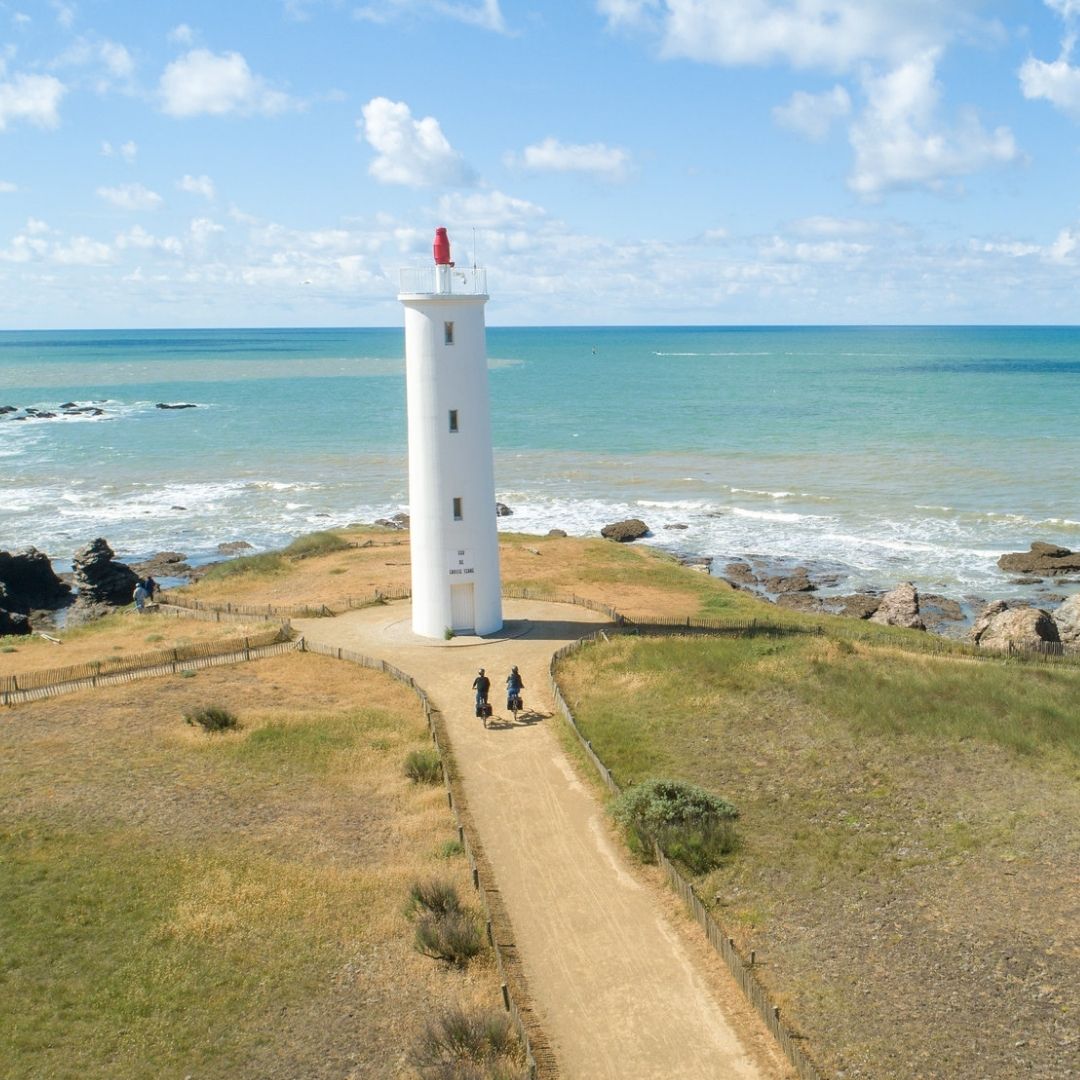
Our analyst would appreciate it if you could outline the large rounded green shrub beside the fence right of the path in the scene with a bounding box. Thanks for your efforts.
[611,780,739,874]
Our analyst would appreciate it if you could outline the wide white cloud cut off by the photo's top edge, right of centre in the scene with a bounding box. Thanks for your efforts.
[599,0,964,71]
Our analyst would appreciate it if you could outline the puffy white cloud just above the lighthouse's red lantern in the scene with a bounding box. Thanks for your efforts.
[356,97,475,188]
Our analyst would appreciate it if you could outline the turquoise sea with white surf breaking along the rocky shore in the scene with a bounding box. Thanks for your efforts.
[0,327,1080,596]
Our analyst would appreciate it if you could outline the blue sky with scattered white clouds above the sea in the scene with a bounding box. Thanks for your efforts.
[0,0,1080,329]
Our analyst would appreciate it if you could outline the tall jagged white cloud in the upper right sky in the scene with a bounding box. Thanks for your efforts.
[848,51,1017,198]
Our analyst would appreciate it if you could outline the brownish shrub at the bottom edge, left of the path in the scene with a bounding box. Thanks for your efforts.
[410,1007,526,1080]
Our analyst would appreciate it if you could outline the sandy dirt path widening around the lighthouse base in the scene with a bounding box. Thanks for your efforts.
[294,600,784,1080]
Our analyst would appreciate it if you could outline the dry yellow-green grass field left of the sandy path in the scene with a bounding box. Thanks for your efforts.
[0,654,500,1080]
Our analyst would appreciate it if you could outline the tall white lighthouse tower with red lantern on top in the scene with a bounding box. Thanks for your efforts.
[397,229,502,637]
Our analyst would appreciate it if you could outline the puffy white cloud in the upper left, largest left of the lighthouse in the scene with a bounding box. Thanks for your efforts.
[158,49,297,117]
